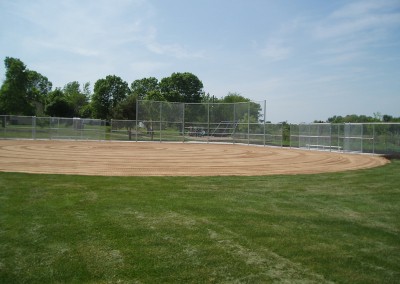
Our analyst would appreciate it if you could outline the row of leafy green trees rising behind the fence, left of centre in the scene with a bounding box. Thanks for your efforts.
[0,57,250,120]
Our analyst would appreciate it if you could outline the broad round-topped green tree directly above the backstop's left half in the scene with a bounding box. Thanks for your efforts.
[159,72,204,103]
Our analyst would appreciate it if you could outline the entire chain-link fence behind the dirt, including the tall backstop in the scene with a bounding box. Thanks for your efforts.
[0,111,400,155]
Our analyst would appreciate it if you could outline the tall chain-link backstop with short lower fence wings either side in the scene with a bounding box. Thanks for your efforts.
[110,100,282,146]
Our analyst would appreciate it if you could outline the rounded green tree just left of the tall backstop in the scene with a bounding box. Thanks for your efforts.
[92,75,129,119]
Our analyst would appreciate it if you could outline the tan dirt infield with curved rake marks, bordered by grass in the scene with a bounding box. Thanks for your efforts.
[0,140,388,176]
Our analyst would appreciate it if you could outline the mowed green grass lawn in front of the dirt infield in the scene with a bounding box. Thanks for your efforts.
[0,160,400,283]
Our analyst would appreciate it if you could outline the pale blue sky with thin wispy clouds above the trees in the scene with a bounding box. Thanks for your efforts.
[0,0,400,123]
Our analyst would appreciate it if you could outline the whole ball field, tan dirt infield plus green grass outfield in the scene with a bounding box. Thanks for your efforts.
[0,140,400,283]
